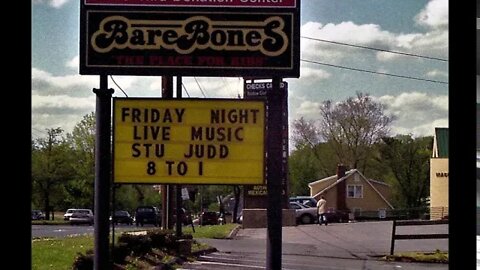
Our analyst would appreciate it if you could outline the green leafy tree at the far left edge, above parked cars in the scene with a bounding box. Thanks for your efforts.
[32,128,73,219]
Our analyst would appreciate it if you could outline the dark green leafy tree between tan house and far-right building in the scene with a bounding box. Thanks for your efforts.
[380,135,433,208]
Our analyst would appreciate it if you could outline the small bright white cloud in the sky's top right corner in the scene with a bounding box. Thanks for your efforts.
[415,0,448,28]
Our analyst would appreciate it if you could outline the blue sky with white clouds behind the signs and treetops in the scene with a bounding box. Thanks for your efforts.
[31,0,448,144]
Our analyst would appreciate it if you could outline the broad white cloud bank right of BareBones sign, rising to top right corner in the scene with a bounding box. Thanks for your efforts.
[300,0,448,64]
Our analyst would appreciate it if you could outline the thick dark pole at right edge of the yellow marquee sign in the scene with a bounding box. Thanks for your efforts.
[266,77,283,270]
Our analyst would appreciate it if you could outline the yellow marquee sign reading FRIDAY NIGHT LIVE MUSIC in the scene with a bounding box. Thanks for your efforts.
[113,98,265,184]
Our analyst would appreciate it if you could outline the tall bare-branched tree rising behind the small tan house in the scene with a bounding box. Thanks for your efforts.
[318,93,393,171]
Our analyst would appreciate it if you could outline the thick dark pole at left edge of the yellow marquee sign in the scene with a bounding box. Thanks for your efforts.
[93,74,113,270]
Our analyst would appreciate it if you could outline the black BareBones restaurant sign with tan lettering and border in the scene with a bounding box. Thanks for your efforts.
[80,0,299,77]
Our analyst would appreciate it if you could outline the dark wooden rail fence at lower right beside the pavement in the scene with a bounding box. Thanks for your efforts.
[390,220,448,255]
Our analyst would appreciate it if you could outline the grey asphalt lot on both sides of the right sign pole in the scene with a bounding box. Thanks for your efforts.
[182,221,448,270]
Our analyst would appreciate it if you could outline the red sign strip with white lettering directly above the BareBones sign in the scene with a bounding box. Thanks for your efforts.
[85,0,297,8]
